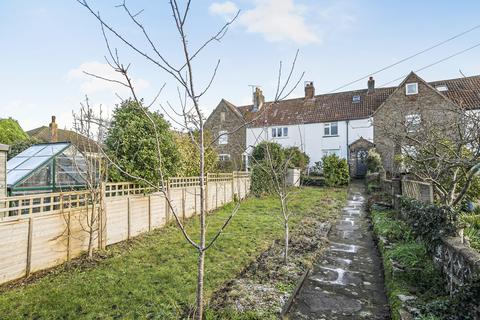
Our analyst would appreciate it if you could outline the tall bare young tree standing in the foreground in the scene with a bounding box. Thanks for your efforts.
[77,0,302,319]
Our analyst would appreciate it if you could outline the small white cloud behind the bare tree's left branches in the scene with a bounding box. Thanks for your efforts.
[67,61,150,94]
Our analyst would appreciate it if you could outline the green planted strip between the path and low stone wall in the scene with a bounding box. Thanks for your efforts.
[372,208,445,320]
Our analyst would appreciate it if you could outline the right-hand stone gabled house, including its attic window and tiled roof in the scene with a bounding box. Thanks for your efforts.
[373,72,480,175]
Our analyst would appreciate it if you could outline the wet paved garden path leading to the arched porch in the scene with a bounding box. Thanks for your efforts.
[289,181,389,320]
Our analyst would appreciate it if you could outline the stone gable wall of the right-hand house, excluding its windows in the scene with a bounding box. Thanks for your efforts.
[373,73,456,173]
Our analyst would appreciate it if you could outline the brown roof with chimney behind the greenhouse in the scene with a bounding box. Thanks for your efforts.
[26,116,100,157]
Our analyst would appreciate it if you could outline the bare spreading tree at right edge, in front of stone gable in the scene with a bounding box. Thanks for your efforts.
[377,97,480,206]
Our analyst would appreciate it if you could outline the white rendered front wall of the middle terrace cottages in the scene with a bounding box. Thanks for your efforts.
[247,118,373,165]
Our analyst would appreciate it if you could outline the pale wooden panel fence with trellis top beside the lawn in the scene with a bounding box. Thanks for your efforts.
[0,172,250,284]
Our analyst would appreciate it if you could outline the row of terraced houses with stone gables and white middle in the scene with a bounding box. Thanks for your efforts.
[206,73,480,176]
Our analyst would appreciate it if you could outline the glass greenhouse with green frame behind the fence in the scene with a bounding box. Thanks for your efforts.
[7,142,87,196]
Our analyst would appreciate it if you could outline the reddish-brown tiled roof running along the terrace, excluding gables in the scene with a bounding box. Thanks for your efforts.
[238,76,480,127]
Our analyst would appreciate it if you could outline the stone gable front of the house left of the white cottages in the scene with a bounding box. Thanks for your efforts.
[205,100,246,171]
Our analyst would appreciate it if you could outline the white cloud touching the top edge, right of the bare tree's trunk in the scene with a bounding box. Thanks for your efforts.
[210,0,321,45]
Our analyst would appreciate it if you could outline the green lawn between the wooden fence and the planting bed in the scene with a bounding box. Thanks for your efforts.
[0,188,346,319]
